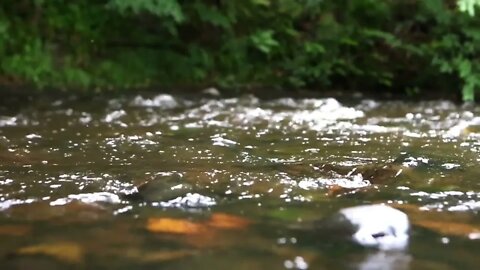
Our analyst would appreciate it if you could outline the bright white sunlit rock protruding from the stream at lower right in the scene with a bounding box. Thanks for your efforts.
[316,204,410,250]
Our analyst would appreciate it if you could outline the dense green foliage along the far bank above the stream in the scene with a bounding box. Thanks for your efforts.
[0,0,480,100]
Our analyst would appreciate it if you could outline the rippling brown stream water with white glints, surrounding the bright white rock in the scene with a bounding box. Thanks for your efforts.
[0,94,480,270]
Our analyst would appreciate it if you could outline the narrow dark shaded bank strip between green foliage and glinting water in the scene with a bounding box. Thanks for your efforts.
[0,86,463,105]
